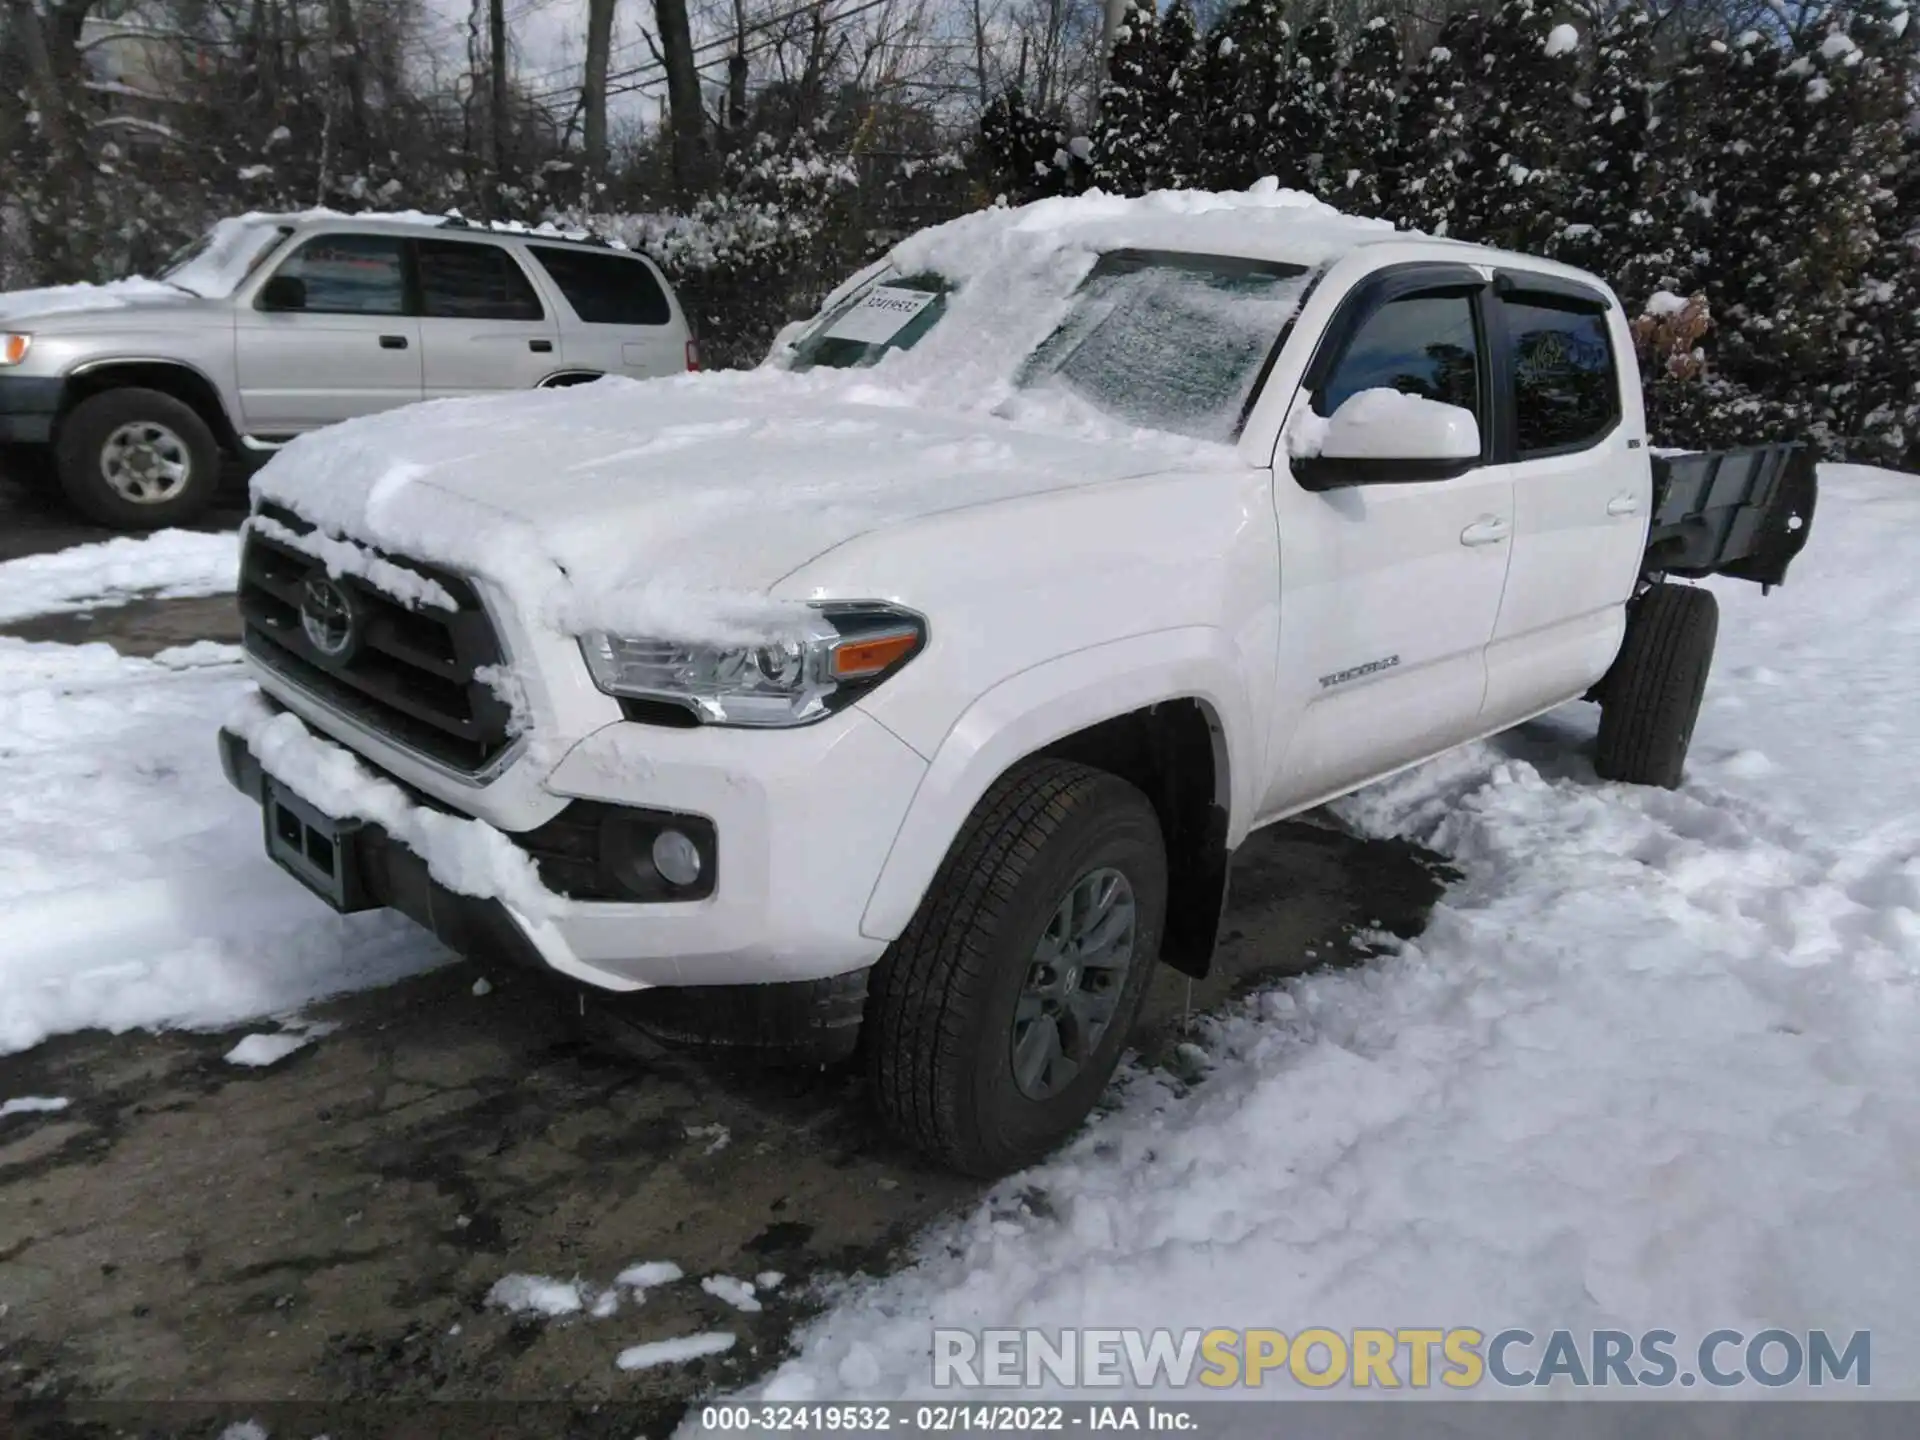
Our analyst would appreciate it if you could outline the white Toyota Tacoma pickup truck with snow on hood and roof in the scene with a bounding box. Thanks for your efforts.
[221,186,1814,1173]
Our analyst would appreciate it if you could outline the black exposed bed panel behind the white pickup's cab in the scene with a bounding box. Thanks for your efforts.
[1644,444,1818,591]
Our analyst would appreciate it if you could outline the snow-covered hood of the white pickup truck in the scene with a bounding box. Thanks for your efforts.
[253,371,1198,639]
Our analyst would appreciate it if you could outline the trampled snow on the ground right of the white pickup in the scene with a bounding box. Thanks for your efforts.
[718,467,1920,1405]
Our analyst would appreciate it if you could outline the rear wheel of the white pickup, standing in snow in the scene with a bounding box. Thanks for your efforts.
[1594,584,1720,789]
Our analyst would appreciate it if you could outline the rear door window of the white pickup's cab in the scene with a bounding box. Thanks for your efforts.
[1501,296,1620,461]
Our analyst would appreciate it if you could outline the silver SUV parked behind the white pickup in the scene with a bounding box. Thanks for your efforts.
[0,211,697,530]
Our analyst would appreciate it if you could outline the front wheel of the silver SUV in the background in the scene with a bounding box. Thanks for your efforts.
[58,388,221,530]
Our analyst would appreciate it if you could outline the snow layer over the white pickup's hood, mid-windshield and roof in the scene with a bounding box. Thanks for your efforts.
[253,184,1392,643]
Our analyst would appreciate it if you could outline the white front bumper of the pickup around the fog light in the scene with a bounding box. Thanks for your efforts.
[221,695,925,991]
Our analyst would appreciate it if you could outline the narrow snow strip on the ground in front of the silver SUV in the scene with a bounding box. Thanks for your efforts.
[0,530,240,624]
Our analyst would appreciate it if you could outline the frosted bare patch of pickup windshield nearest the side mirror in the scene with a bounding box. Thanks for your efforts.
[1018,250,1308,442]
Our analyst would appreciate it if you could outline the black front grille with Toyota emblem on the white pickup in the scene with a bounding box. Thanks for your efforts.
[240,505,513,774]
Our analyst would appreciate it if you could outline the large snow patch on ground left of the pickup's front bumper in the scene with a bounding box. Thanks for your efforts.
[0,637,445,1052]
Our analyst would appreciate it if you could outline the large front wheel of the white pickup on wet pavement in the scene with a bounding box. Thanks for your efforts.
[862,760,1167,1177]
